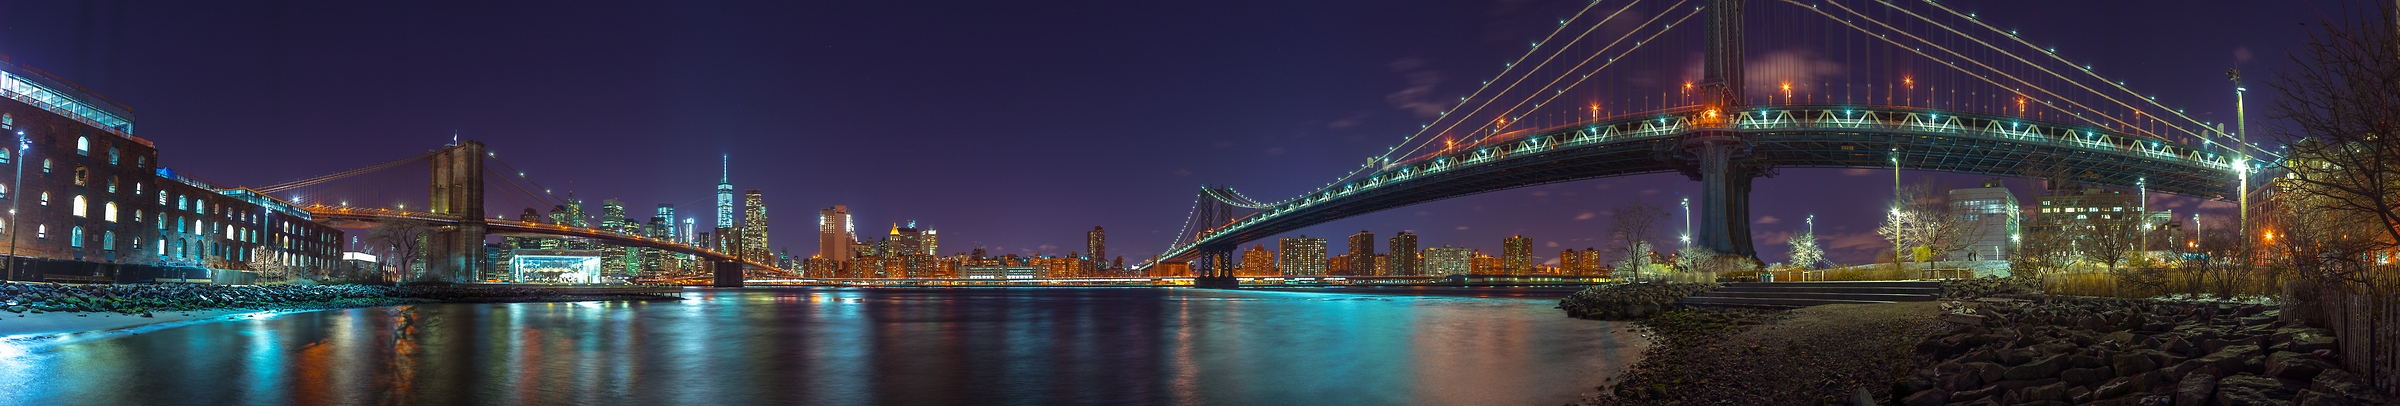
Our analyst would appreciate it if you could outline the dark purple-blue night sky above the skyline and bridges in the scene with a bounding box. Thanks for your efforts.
[0,0,2342,262]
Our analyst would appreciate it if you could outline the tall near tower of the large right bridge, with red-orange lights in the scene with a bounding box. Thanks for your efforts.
[1675,0,1774,257]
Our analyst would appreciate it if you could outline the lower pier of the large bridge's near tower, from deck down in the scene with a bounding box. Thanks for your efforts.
[1682,130,1771,262]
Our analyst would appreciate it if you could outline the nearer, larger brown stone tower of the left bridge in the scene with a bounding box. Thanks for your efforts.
[425,139,485,281]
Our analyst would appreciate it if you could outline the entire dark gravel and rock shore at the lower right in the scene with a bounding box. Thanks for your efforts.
[1560,279,2395,406]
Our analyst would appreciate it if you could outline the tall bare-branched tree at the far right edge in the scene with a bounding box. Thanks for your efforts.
[2270,2,2400,288]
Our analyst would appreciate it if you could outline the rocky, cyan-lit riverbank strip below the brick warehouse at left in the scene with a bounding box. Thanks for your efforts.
[0,281,682,336]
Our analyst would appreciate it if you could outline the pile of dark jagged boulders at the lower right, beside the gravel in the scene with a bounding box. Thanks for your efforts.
[1894,295,2386,406]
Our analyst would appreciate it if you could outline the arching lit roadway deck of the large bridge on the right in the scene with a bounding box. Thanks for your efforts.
[1162,106,2237,262]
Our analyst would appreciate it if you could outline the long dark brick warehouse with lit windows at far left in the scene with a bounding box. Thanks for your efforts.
[0,55,343,283]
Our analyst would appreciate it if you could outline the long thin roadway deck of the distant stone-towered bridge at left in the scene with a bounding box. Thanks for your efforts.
[302,204,782,271]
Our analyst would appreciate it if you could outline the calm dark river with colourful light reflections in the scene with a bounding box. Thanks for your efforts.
[0,288,1646,406]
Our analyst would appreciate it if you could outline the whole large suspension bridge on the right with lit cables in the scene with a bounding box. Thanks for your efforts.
[1142,0,2280,281]
